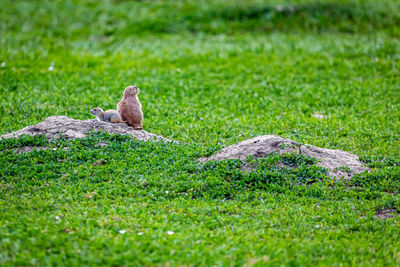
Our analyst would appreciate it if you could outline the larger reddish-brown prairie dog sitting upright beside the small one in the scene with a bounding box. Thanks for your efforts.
[117,85,143,130]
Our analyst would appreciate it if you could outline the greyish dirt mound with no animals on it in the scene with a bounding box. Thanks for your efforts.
[200,135,369,179]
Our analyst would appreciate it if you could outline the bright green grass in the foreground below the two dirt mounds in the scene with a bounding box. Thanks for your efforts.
[0,134,400,265]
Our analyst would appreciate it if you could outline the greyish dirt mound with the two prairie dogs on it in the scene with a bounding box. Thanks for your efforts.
[0,116,171,141]
